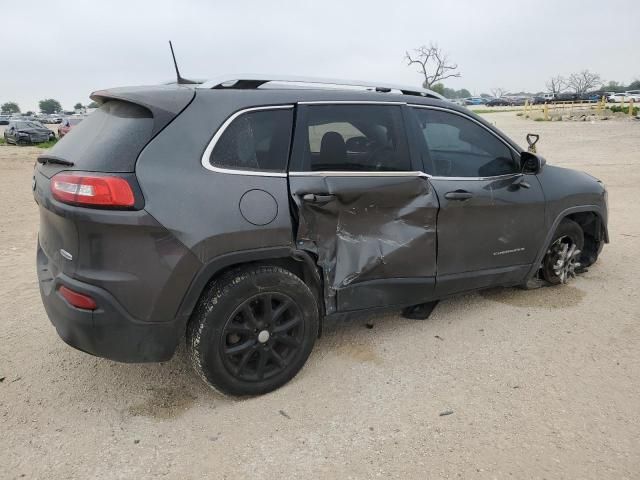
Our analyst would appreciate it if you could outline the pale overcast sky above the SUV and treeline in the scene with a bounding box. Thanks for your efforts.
[0,0,640,111]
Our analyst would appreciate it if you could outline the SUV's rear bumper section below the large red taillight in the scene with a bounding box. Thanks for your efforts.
[35,176,202,362]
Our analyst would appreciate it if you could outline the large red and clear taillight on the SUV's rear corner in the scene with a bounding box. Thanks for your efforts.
[51,173,135,207]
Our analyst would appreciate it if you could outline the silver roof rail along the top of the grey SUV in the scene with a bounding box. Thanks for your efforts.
[196,74,444,99]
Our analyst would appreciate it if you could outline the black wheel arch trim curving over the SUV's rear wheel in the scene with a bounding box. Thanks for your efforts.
[177,247,324,331]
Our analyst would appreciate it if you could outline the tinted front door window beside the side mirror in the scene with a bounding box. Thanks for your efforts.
[414,108,519,177]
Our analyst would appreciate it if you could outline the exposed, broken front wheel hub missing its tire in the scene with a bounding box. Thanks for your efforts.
[542,218,584,285]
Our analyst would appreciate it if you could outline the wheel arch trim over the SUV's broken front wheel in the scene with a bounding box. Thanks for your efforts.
[526,205,609,281]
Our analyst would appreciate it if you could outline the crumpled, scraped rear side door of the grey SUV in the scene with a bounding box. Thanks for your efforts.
[289,103,438,313]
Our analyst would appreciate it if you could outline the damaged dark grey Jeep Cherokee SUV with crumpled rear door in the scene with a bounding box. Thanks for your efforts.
[33,76,608,395]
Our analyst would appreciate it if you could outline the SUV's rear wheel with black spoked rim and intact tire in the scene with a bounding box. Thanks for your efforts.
[187,266,319,396]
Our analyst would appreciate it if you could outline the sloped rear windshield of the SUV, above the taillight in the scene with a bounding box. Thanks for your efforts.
[50,100,153,172]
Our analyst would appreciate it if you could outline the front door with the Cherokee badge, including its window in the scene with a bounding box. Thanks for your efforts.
[409,105,546,297]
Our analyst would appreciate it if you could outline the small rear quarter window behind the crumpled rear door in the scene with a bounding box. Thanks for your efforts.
[209,108,293,172]
